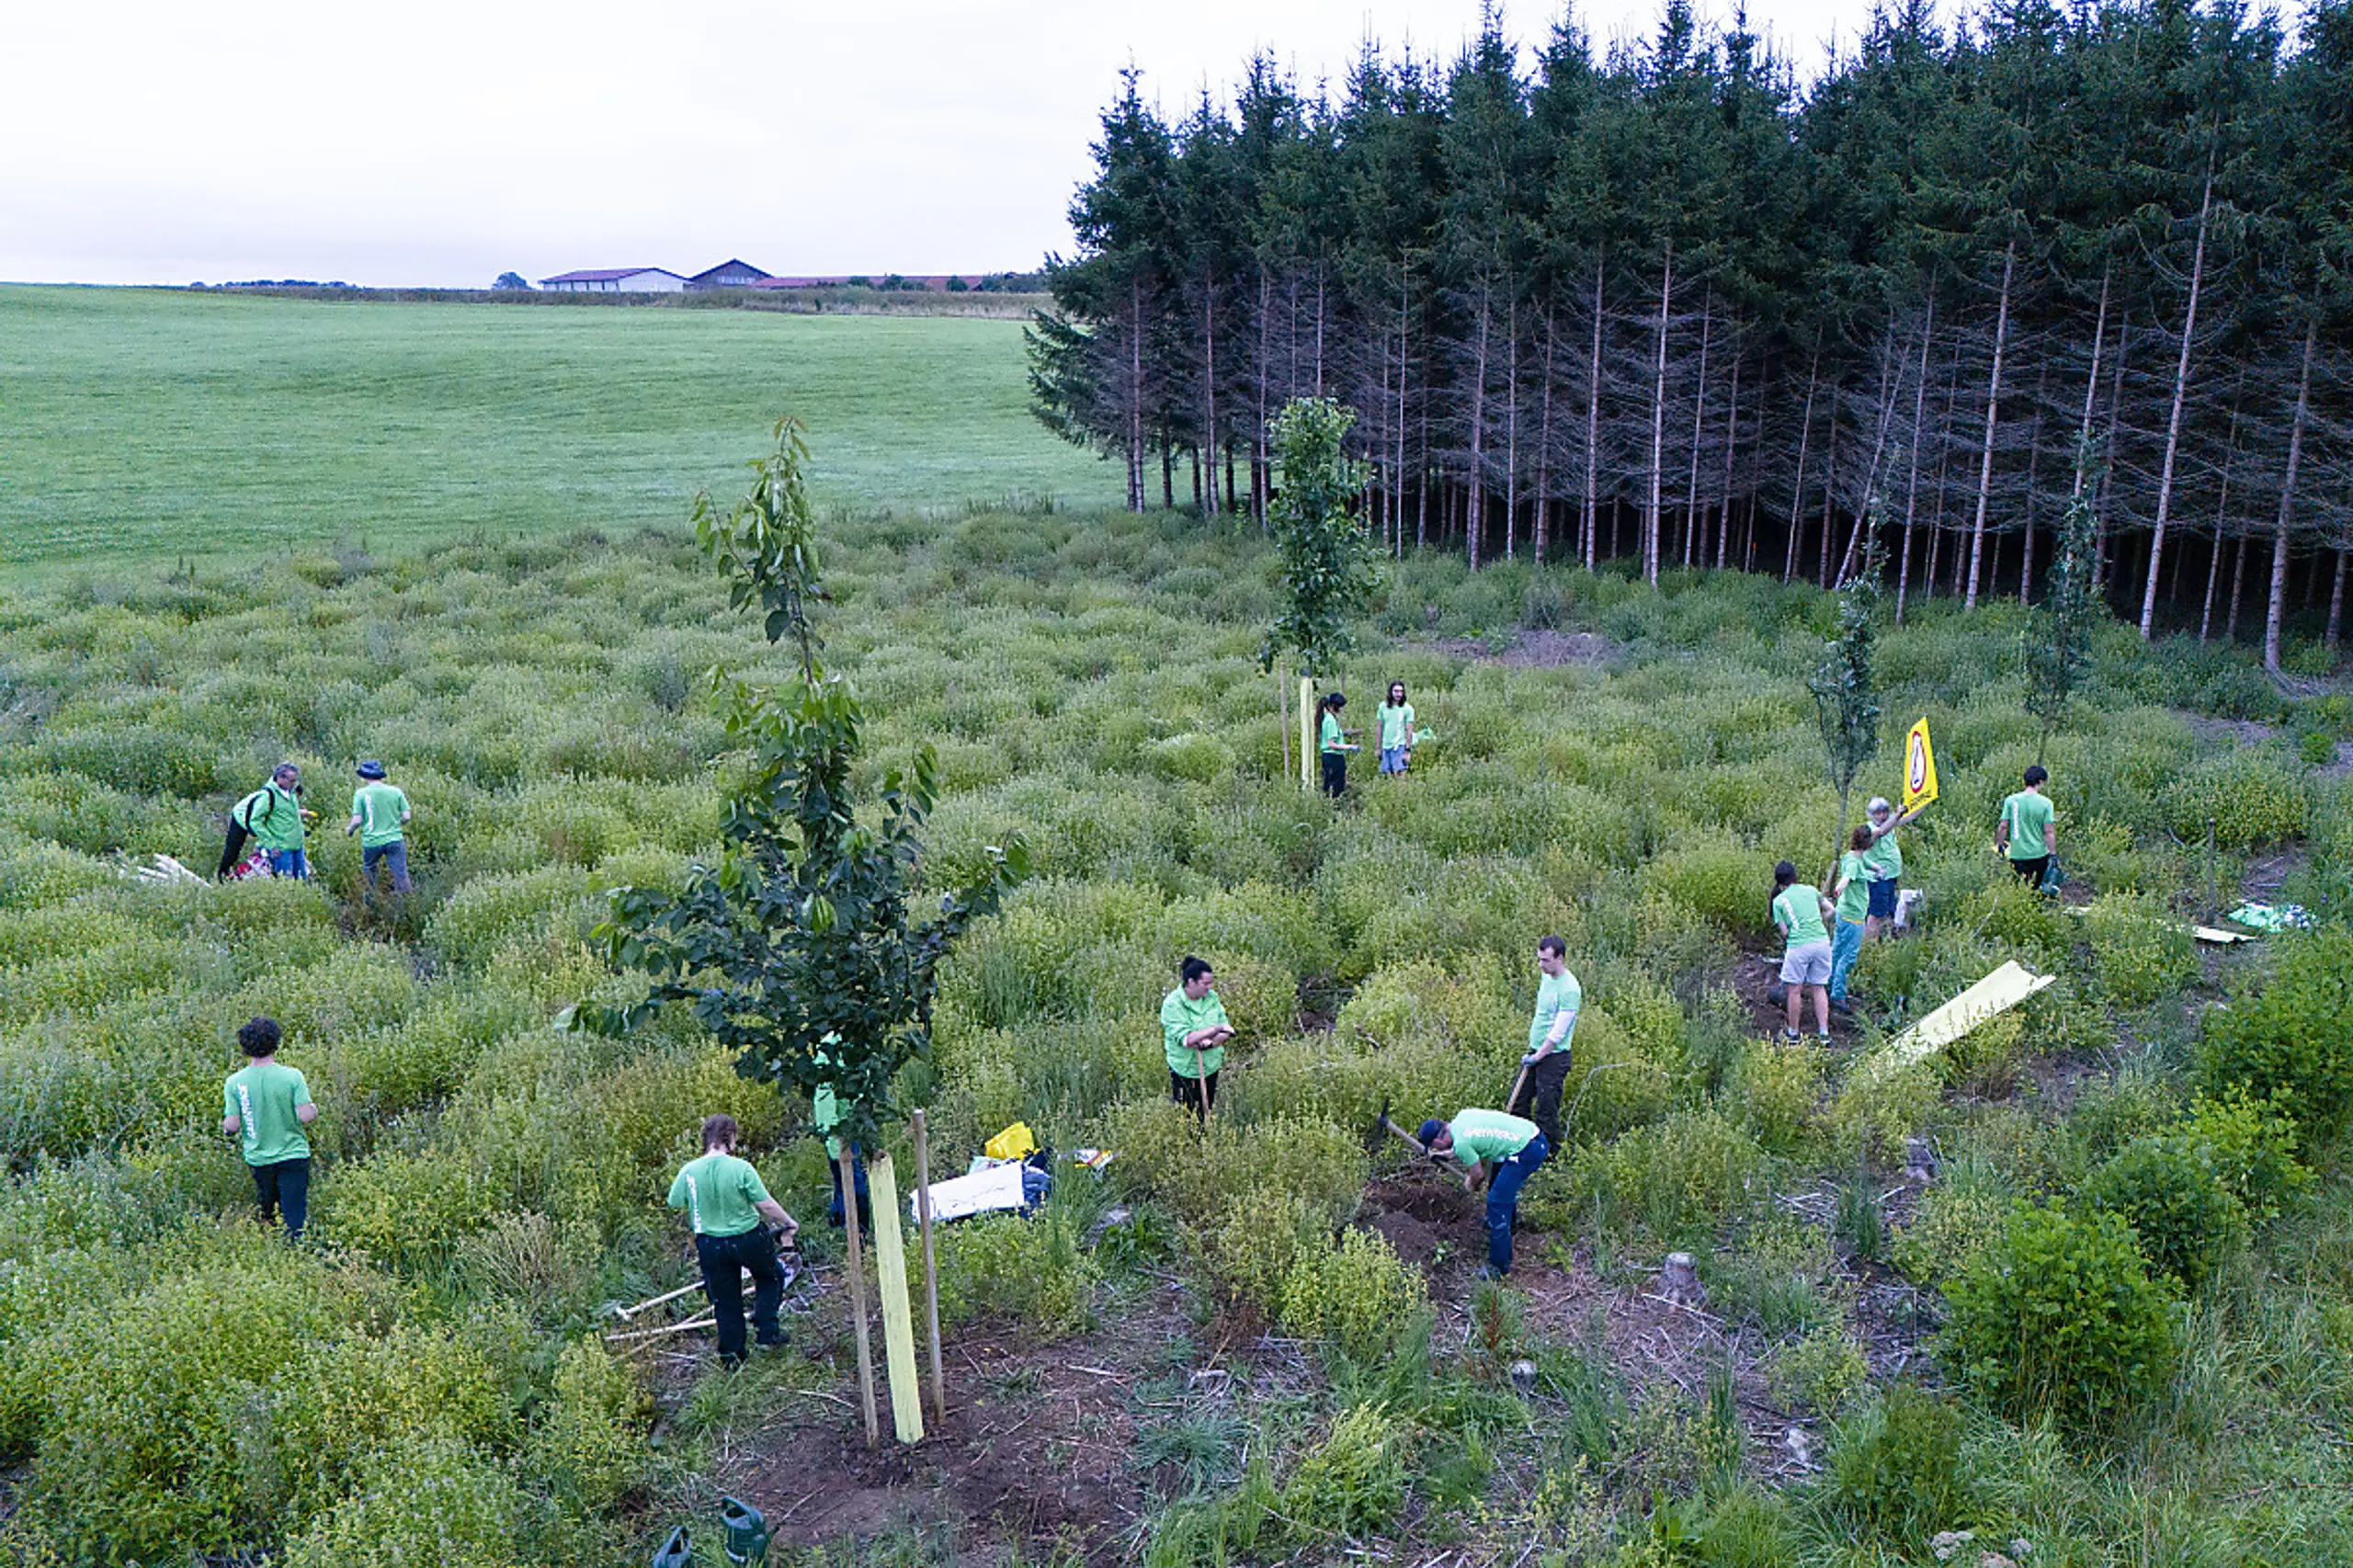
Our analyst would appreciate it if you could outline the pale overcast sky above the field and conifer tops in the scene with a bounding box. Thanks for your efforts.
[0,0,1869,288]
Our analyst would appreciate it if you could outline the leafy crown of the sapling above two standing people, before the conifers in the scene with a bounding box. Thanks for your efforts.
[1259,398,1381,676]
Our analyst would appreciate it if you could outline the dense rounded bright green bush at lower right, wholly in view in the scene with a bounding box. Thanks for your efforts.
[1944,1208,2174,1426]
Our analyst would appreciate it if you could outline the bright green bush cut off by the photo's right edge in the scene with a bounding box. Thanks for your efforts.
[2200,927,2353,1140]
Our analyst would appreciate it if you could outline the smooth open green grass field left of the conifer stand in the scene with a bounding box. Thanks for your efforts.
[0,288,1118,574]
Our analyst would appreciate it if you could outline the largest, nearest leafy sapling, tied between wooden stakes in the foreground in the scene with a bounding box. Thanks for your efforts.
[581,419,1029,1425]
